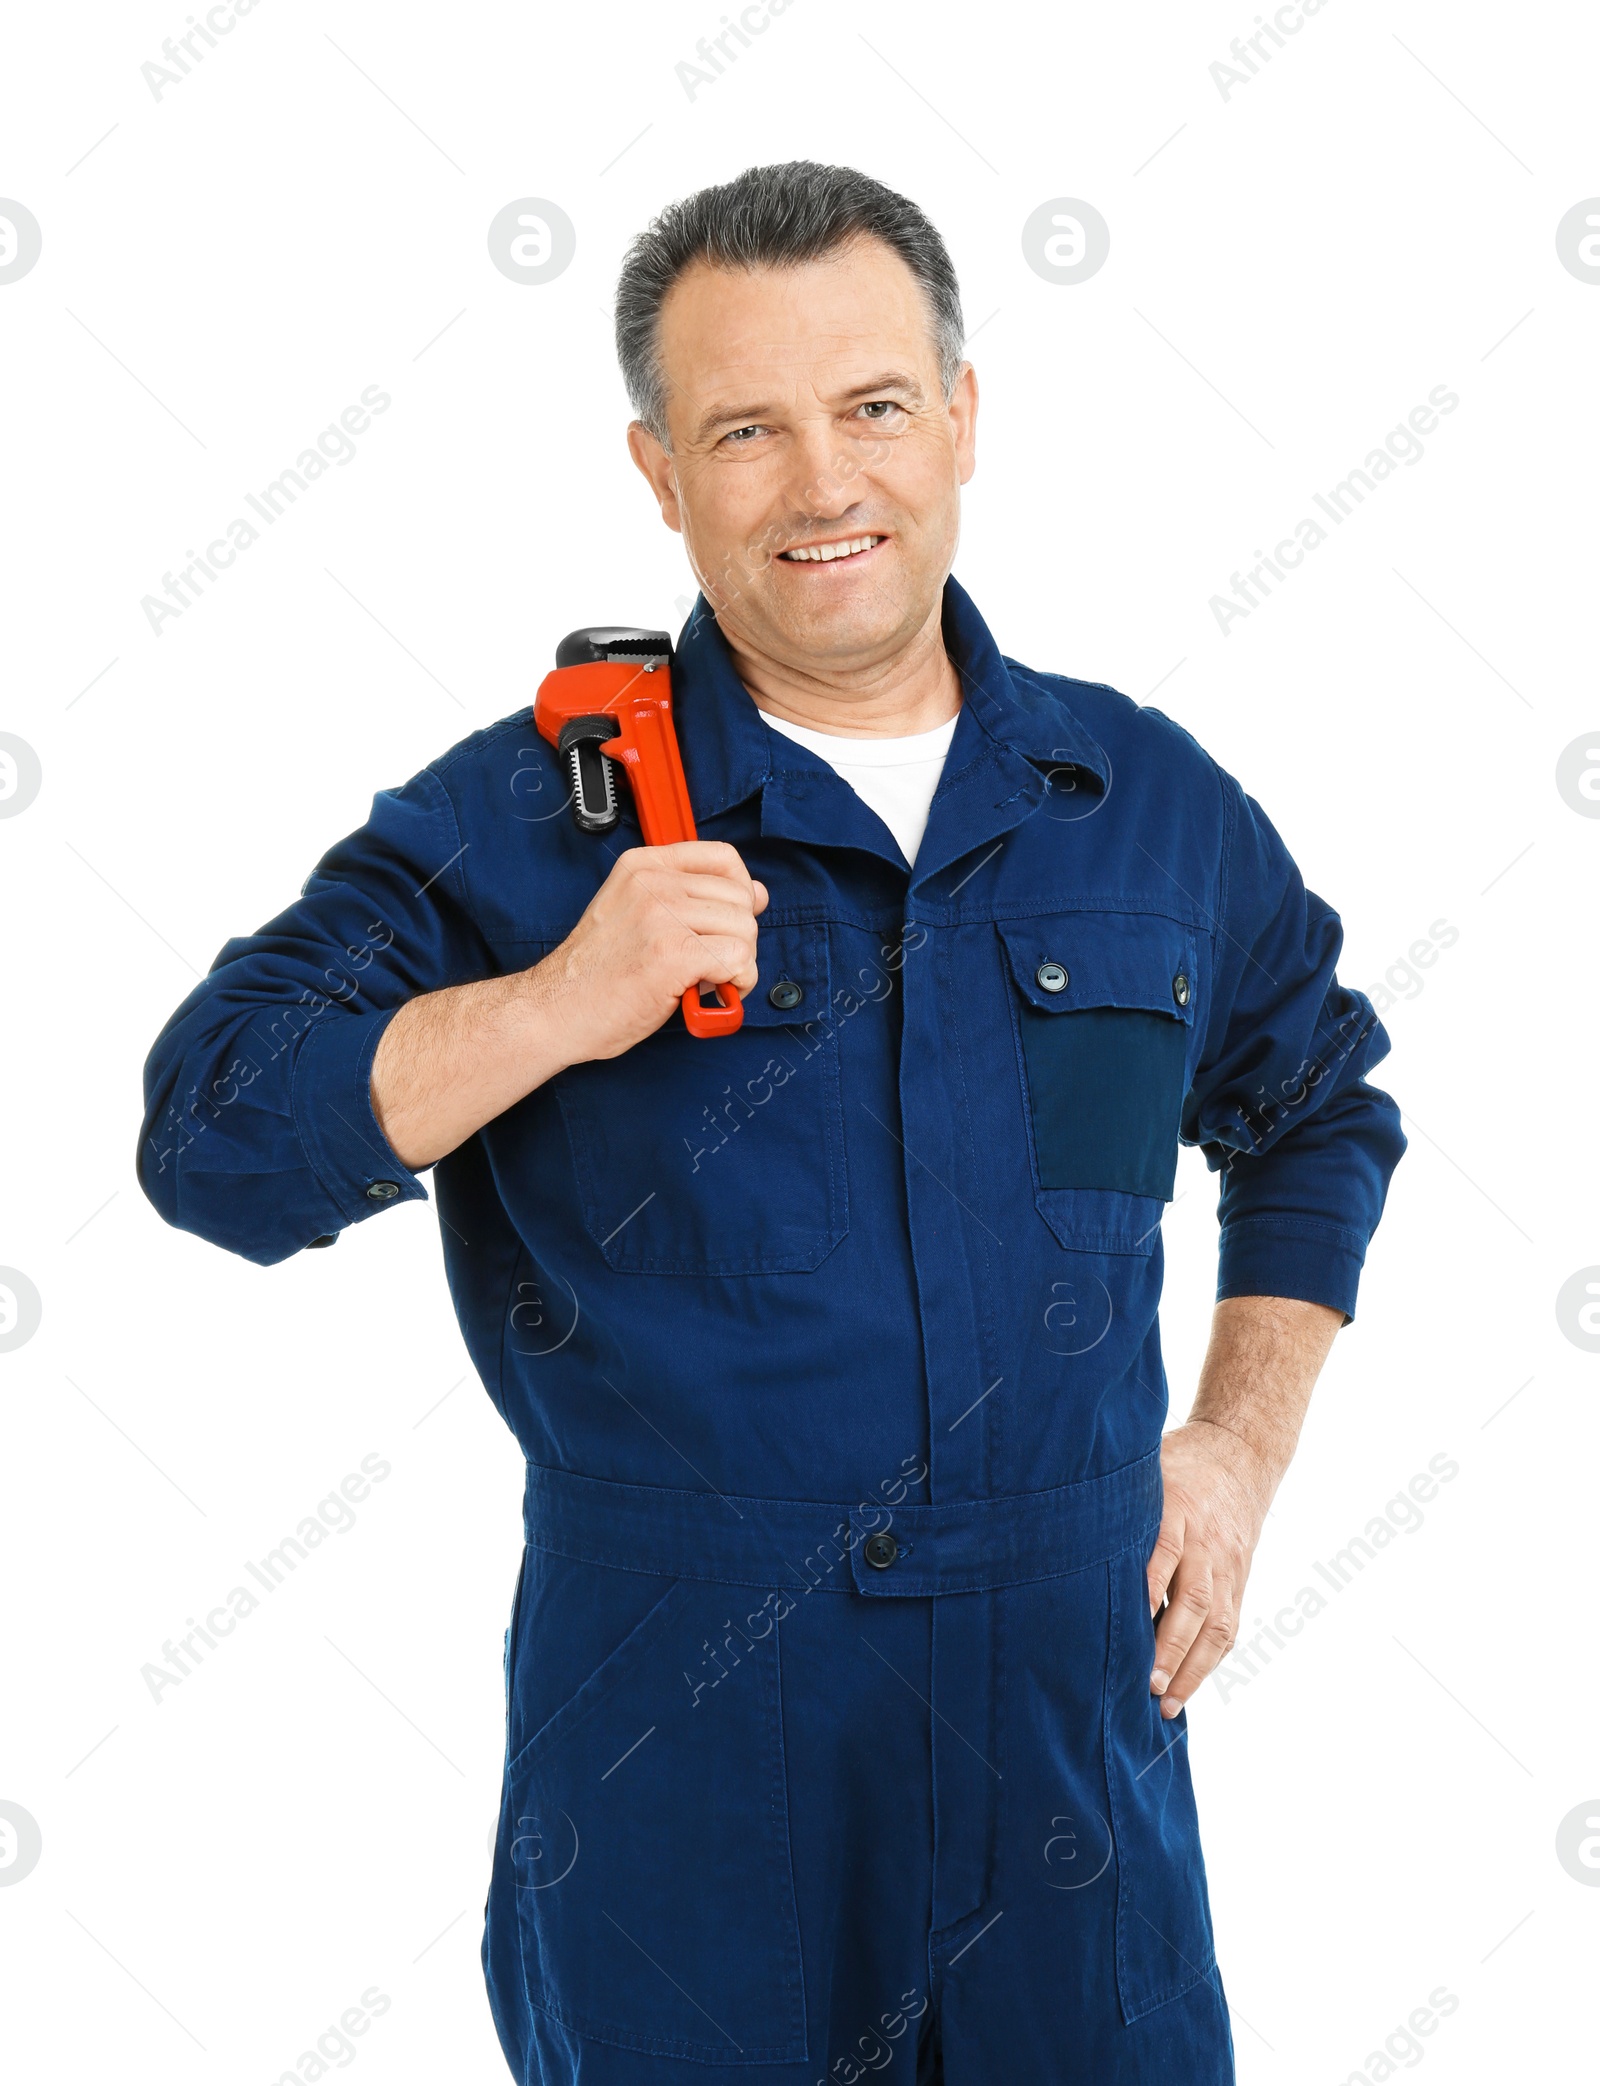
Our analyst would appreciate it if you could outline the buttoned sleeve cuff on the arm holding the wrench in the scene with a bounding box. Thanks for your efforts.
[292,1008,428,1224]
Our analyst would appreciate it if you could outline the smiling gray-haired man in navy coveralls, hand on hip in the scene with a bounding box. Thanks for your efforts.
[140,163,1404,2086]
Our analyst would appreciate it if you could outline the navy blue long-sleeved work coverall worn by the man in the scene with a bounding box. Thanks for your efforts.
[140,580,1404,2086]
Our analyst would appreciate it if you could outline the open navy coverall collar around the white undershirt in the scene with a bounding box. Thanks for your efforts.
[674,578,1110,882]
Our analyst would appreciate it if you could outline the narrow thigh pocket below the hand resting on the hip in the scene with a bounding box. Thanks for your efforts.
[1106,1539,1216,2021]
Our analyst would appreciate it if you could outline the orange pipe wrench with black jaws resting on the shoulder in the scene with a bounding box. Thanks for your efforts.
[534,628,745,1037]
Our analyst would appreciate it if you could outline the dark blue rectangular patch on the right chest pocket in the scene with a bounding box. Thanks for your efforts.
[1018,1001,1187,1202]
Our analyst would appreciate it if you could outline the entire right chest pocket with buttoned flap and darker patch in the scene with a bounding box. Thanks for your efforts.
[999,914,1199,1254]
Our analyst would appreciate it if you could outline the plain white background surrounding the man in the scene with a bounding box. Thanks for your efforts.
[0,0,1600,2086]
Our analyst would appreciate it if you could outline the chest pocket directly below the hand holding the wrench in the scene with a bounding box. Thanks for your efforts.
[553,922,849,1275]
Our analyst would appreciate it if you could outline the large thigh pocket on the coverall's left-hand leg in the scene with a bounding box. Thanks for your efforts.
[507,1579,805,2065]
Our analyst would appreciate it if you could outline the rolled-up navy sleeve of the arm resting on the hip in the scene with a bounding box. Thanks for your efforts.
[1181,774,1406,1318]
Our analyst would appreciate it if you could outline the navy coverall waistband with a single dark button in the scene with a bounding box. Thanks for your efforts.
[522,1450,1162,1598]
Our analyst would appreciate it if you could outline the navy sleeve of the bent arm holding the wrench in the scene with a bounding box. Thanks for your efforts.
[138,768,492,1266]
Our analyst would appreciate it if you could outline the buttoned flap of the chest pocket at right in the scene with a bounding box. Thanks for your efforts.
[995,914,1195,1022]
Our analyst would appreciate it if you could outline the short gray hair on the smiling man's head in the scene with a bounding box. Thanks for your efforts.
[617,159,966,448]
